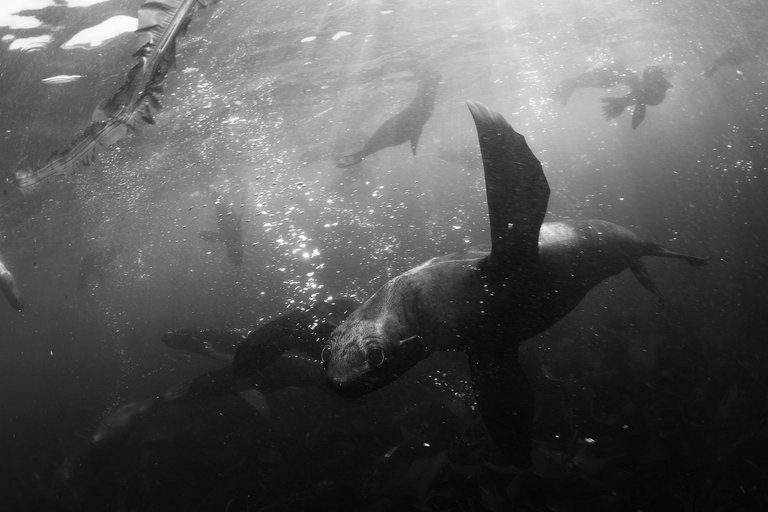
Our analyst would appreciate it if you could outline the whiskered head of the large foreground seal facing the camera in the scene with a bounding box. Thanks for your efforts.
[322,315,429,397]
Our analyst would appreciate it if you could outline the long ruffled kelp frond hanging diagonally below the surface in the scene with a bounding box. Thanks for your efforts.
[16,0,218,188]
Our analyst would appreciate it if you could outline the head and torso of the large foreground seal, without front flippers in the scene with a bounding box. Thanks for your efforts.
[326,219,704,393]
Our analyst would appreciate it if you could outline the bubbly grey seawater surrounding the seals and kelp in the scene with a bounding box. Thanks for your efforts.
[0,0,768,512]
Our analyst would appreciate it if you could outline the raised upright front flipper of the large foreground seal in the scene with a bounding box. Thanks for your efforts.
[467,101,549,270]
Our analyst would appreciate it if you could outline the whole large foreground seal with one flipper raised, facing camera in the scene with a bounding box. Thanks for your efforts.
[321,102,708,466]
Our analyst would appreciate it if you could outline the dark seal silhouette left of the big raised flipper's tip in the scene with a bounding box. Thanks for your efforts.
[336,71,442,167]
